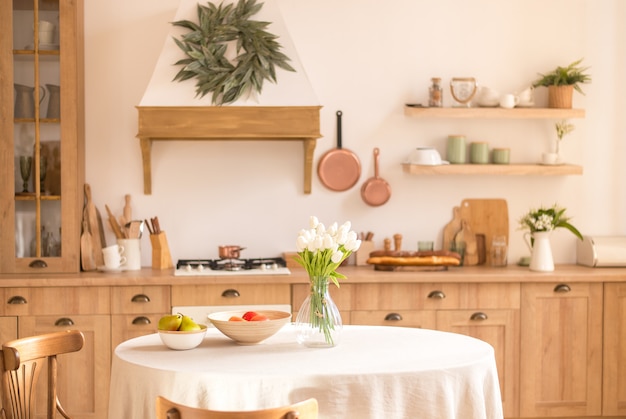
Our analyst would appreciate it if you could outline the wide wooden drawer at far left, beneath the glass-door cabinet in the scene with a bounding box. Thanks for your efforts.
[0,287,111,316]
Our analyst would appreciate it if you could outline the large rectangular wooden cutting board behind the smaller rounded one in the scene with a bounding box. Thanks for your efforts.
[460,199,509,265]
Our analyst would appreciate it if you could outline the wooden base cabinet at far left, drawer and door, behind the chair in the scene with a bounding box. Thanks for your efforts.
[0,287,111,419]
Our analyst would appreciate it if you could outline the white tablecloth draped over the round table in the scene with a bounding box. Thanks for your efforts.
[109,325,503,419]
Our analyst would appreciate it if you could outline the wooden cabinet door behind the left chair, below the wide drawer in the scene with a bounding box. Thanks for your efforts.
[19,315,111,419]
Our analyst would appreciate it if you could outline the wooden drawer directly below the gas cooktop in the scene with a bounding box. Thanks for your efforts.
[172,284,291,306]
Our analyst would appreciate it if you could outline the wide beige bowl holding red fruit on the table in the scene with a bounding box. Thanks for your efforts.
[209,310,291,345]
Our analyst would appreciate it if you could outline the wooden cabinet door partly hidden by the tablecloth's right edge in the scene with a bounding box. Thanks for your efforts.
[437,309,519,417]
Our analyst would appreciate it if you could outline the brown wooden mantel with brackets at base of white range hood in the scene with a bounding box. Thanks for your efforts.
[137,106,322,195]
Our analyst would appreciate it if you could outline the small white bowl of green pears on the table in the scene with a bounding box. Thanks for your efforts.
[158,313,207,351]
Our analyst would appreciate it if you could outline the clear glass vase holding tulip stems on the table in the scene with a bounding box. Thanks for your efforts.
[296,276,343,348]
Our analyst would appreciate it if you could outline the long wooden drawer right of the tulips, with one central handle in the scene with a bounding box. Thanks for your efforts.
[354,283,520,310]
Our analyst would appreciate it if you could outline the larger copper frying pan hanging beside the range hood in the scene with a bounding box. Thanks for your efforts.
[317,111,361,192]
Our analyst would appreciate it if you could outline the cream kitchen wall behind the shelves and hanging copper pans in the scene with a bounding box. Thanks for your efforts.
[85,0,626,266]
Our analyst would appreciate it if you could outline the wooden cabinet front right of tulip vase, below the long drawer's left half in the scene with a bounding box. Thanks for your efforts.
[350,310,436,329]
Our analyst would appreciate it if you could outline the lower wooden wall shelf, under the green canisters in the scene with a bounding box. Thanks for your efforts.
[402,163,583,176]
